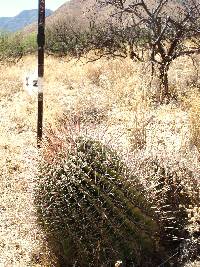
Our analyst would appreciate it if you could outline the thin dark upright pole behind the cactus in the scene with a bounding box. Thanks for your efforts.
[37,0,45,148]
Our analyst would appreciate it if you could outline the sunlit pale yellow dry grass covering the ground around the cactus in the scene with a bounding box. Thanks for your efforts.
[0,56,200,267]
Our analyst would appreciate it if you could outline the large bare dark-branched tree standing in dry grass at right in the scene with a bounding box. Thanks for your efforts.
[97,0,200,102]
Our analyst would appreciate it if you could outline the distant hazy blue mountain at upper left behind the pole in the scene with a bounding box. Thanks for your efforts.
[0,9,53,32]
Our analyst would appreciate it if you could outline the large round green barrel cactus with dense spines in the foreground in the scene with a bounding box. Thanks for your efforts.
[35,138,167,267]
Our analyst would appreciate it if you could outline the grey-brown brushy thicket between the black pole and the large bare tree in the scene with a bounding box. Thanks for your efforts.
[46,18,143,60]
